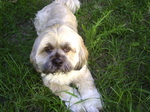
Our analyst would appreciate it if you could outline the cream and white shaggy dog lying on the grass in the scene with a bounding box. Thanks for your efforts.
[30,0,102,112]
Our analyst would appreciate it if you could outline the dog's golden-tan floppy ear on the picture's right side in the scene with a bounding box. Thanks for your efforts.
[75,42,89,70]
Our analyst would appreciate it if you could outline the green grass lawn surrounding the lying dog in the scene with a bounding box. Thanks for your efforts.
[0,0,150,112]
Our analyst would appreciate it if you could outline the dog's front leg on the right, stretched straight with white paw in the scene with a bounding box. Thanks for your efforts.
[77,70,102,112]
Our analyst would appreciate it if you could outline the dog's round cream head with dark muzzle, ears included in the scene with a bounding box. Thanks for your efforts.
[30,26,88,74]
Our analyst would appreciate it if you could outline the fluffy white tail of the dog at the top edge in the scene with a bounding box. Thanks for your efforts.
[55,0,80,13]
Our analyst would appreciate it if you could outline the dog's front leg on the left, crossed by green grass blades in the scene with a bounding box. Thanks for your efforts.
[49,83,84,112]
